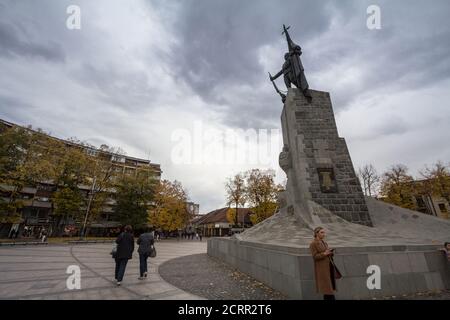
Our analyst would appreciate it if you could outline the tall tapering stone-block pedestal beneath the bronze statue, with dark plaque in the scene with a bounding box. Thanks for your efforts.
[280,89,372,226]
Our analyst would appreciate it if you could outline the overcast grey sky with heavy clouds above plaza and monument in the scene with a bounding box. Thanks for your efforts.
[0,0,450,213]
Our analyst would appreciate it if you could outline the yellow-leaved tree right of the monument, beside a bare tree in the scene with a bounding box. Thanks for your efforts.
[380,164,415,210]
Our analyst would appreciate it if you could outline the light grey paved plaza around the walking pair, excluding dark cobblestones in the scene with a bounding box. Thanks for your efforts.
[0,239,206,300]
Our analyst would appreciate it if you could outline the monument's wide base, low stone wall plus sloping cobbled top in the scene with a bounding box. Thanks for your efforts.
[208,198,450,299]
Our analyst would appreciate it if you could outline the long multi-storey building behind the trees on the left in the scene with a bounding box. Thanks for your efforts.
[0,120,162,238]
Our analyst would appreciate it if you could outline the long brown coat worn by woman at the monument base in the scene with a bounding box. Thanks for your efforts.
[309,239,334,295]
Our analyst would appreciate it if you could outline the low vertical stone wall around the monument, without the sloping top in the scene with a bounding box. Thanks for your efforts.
[208,238,450,300]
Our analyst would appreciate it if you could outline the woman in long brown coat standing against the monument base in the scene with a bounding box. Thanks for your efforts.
[309,227,340,300]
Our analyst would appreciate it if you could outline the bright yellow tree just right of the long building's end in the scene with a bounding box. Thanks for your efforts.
[148,180,192,232]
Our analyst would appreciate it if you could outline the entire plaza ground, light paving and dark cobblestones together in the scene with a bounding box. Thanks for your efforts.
[0,240,450,300]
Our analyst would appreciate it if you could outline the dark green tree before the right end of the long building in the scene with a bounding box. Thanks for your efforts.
[115,169,156,229]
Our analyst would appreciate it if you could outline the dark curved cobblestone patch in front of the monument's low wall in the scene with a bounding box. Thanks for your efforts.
[159,254,287,300]
